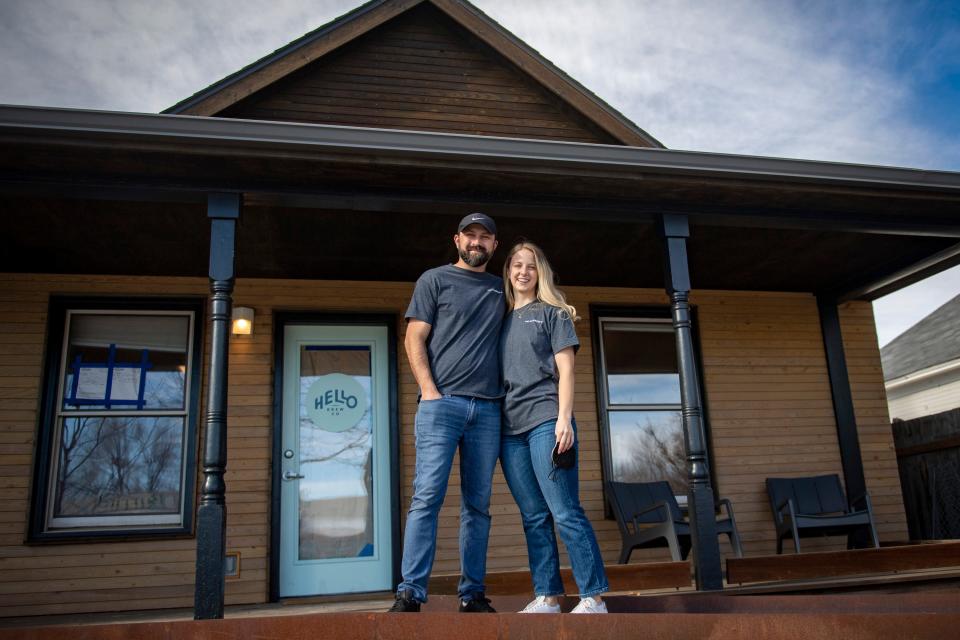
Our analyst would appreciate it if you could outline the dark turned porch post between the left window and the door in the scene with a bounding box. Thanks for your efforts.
[193,193,240,620]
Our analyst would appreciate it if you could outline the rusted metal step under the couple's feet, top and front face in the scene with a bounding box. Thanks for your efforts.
[0,592,960,640]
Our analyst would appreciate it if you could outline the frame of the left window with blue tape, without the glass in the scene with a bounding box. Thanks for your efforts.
[27,296,205,542]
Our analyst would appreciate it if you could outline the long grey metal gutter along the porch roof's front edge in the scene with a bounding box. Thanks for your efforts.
[0,105,960,191]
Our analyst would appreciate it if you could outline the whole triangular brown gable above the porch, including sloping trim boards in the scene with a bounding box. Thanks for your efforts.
[163,0,664,148]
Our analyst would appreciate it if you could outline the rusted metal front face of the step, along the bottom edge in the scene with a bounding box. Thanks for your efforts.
[0,613,960,640]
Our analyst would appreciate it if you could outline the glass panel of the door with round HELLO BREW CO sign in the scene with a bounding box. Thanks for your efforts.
[298,345,375,560]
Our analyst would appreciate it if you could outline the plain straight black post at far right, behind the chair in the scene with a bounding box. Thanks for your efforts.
[817,296,867,496]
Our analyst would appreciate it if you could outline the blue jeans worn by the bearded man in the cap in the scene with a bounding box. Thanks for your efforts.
[397,395,500,602]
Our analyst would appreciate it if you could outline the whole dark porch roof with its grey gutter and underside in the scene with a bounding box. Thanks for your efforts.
[0,106,960,299]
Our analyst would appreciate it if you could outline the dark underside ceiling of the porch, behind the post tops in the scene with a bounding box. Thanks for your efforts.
[0,196,955,292]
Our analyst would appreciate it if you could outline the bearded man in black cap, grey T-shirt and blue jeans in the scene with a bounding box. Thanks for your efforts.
[390,213,504,613]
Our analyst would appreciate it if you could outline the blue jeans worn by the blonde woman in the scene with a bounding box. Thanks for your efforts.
[500,420,609,597]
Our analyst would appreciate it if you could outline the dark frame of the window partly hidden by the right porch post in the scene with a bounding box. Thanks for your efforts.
[590,305,717,510]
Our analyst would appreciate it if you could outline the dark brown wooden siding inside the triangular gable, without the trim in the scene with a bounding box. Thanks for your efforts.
[216,4,619,144]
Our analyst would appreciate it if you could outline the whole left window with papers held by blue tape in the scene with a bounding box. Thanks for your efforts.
[31,299,201,539]
